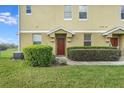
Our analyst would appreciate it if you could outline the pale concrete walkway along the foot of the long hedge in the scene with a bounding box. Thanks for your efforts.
[67,58,124,65]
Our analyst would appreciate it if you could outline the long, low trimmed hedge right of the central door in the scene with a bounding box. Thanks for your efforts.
[68,47,121,61]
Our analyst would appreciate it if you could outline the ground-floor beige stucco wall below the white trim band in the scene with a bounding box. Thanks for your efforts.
[21,33,108,54]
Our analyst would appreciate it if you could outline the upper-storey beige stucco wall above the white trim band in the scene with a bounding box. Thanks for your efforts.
[20,5,124,31]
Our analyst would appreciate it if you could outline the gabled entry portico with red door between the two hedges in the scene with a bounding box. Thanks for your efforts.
[48,27,75,56]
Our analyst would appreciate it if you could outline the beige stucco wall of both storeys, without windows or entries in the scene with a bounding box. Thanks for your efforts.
[19,5,124,55]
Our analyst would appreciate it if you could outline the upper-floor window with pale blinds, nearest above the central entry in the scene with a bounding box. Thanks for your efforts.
[64,5,72,20]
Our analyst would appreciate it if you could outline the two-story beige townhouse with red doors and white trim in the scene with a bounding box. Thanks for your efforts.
[19,5,124,56]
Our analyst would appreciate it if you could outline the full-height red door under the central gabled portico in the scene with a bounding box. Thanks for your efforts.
[56,35,65,55]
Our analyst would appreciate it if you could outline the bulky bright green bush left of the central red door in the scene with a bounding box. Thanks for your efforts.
[23,45,52,66]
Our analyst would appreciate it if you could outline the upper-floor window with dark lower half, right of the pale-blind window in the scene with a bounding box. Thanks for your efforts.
[79,5,87,19]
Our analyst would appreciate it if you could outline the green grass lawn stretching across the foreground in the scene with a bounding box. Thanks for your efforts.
[0,50,124,88]
